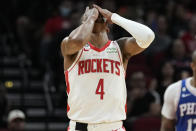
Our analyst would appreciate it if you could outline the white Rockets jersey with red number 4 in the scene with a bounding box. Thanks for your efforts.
[65,41,127,124]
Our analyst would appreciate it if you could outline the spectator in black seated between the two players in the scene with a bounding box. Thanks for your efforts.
[125,72,161,130]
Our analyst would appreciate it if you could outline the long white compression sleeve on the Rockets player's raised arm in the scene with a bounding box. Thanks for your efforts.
[111,13,155,48]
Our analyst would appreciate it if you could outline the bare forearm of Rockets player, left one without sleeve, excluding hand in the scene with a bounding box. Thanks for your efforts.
[69,18,95,46]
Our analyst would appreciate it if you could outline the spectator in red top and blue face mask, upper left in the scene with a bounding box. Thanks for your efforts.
[40,0,73,68]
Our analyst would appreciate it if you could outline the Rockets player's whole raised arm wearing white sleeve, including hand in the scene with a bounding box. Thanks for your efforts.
[94,5,155,59]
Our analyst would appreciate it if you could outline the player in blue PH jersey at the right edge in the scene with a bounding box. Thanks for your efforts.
[161,51,196,131]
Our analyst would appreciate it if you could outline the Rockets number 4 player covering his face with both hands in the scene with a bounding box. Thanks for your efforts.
[61,5,154,131]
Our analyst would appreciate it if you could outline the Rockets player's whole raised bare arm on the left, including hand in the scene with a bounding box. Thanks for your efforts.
[61,7,99,56]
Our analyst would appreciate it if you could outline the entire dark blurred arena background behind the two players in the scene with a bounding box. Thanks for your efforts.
[0,0,196,131]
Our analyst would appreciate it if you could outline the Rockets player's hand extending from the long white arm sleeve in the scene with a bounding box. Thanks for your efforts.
[93,4,113,24]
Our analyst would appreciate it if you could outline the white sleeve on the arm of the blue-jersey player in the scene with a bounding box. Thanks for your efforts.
[161,82,181,120]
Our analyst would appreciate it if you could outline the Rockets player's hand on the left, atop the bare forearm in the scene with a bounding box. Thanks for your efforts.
[84,6,99,21]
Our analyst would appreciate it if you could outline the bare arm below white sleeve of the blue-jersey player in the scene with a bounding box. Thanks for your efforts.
[161,116,175,131]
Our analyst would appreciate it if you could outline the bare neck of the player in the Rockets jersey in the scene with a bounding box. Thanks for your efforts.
[90,32,109,48]
